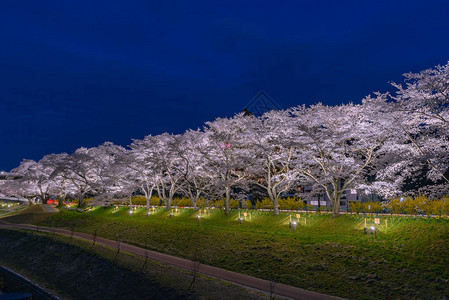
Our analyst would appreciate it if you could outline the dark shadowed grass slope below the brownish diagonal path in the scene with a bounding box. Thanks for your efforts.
[0,230,266,300]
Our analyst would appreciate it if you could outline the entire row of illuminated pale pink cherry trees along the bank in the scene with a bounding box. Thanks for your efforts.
[1,64,449,216]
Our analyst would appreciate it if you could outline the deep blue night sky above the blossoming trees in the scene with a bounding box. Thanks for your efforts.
[0,0,449,170]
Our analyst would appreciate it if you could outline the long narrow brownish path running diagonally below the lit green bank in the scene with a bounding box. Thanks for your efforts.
[0,220,342,300]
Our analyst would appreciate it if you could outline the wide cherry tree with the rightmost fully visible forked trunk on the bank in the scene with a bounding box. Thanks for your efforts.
[286,99,406,216]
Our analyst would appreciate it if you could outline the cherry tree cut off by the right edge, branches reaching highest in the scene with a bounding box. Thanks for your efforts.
[392,63,449,189]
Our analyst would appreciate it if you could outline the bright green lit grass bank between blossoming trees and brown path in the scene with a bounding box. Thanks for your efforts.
[39,208,449,299]
